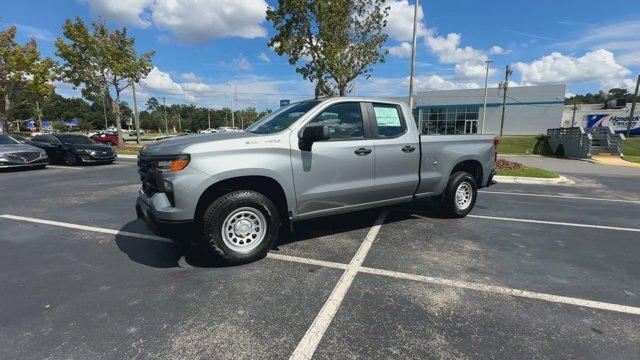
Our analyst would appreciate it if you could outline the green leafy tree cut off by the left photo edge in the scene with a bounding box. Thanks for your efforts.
[0,26,56,131]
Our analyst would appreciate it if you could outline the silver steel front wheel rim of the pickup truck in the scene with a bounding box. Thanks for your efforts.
[222,207,267,253]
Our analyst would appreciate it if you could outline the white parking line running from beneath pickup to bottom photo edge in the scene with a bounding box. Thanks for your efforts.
[289,210,387,360]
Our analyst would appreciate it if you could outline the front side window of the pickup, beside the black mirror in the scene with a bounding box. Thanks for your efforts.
[309,102,364,140]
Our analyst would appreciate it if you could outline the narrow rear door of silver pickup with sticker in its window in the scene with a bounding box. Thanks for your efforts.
[367,102,420,202]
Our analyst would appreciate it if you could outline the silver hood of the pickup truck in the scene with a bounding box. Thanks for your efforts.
[140,131,260,156]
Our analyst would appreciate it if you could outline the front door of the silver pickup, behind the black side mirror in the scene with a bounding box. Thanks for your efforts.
[291,102,375,217]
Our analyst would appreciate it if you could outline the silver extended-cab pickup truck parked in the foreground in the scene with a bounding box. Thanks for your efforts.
[136,97,497,263]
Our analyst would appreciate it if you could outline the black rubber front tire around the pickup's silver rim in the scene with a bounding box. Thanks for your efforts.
[202,190,280,264]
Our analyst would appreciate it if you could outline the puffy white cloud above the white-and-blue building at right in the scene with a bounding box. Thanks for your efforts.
[513,49,631,88]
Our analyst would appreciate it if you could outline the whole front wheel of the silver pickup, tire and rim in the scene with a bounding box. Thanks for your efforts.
[203,190,280,264]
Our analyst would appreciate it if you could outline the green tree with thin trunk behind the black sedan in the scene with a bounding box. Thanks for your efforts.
[56,17,154,144]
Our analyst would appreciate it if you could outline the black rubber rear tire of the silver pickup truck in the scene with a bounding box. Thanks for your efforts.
[441,171,478,218]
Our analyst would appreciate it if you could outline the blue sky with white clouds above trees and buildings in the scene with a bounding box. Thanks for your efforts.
[0,0,640,108]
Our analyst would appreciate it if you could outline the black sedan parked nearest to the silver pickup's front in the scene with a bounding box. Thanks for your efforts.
[29,133,117,166]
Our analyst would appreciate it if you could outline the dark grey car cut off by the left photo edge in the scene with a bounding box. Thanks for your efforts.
[0,134,49,169]
